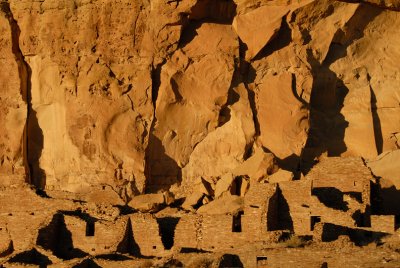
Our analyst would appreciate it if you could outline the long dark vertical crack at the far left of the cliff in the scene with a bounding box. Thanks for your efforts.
[0,2,45,189]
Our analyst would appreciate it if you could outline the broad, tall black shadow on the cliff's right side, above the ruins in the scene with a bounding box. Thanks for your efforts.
[301,51,349,173]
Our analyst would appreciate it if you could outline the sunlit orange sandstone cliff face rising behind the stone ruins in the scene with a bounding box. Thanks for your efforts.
[0,0,400,200]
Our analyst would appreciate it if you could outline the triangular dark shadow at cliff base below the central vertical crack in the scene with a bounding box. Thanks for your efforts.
[145,133,182,193]
